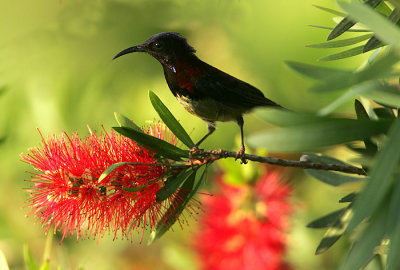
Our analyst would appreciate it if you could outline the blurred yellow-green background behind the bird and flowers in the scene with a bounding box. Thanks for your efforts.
[0,0,364,269]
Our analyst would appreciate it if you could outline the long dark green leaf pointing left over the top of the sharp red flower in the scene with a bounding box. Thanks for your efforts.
[113,127,189,160]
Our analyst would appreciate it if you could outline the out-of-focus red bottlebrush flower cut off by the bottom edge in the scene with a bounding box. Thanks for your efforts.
[194,172,291,270]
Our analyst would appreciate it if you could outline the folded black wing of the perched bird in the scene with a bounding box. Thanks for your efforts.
[194,69,280,109]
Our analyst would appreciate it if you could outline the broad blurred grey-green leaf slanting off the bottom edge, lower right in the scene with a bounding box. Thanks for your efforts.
[339,202,388,270]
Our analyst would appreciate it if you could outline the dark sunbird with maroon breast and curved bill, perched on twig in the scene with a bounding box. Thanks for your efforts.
[113,32,283,163]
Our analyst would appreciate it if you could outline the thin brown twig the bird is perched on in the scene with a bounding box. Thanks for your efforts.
[196,149,367,175]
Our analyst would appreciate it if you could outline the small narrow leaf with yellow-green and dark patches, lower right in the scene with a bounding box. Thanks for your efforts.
[315,204,351,255]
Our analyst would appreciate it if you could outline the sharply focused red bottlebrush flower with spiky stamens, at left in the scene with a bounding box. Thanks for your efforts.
[22,123,191,244]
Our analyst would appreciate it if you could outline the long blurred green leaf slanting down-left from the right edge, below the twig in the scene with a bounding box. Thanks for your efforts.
[348,119,400,231]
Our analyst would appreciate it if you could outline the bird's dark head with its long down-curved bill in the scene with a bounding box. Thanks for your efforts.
[113,32,196,63]
